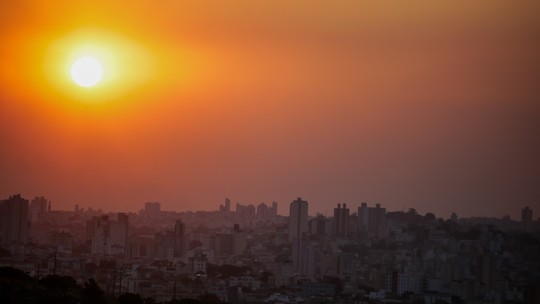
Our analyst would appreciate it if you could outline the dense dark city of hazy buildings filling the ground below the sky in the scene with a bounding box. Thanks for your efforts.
[0,195,540,304]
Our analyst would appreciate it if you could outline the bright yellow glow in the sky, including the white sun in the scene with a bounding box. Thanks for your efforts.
[40,28,158,104]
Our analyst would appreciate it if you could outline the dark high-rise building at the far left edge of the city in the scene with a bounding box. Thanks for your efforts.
[0,194,28,244]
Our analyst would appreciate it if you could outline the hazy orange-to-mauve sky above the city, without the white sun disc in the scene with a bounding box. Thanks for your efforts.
[0,0,540,218]
